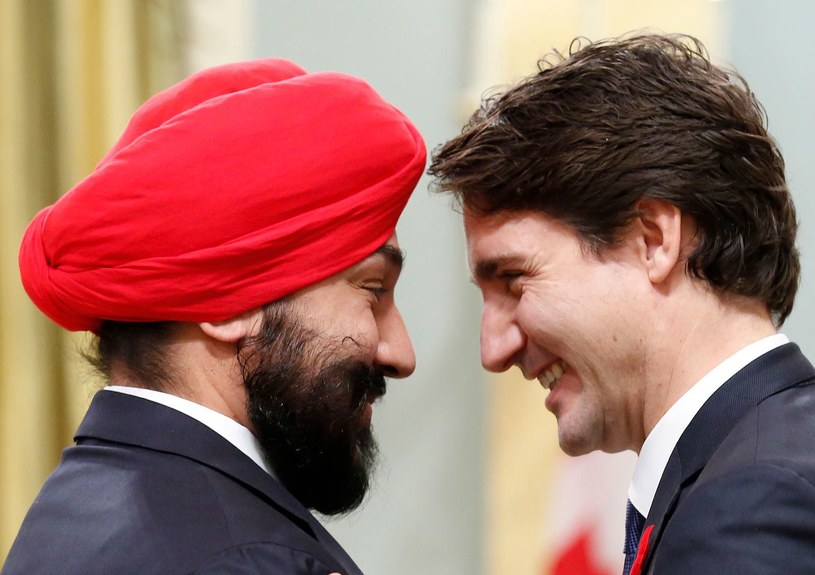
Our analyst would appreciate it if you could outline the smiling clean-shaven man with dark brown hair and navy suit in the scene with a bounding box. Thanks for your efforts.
[430,35,815,575]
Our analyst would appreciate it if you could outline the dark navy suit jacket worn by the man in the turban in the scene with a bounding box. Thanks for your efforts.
[2,391,361,575]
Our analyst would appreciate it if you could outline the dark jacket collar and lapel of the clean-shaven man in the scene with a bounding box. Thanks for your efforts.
[642,343,815,573]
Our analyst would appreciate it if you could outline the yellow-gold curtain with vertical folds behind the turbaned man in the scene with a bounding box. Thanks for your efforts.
[0,0,181,563]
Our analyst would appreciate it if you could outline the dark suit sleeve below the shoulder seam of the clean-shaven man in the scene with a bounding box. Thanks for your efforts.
[653,463,815,575]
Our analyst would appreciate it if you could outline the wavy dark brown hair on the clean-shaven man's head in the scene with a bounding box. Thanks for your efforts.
[429,35,800,325]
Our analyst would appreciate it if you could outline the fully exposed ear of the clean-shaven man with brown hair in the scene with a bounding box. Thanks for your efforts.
[633,198,688,284]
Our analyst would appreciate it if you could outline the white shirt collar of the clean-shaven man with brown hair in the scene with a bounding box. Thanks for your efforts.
[628,334,789,517]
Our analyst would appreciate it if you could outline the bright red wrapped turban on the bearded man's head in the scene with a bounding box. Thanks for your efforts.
[20,59,426,331]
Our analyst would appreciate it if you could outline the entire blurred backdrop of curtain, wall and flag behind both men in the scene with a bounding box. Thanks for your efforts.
[0,0,815,575]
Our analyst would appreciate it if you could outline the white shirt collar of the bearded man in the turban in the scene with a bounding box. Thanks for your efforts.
[104,385,274,476]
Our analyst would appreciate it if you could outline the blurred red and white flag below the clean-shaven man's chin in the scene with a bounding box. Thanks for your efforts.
[541,452,636,575]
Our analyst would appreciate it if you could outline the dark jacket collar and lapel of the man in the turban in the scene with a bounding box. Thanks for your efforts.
[74,391,361,575]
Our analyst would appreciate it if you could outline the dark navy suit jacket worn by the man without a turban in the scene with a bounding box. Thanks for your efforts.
[642,344,815,575]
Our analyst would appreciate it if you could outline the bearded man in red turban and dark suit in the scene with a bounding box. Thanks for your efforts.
[3,59,426,575]
